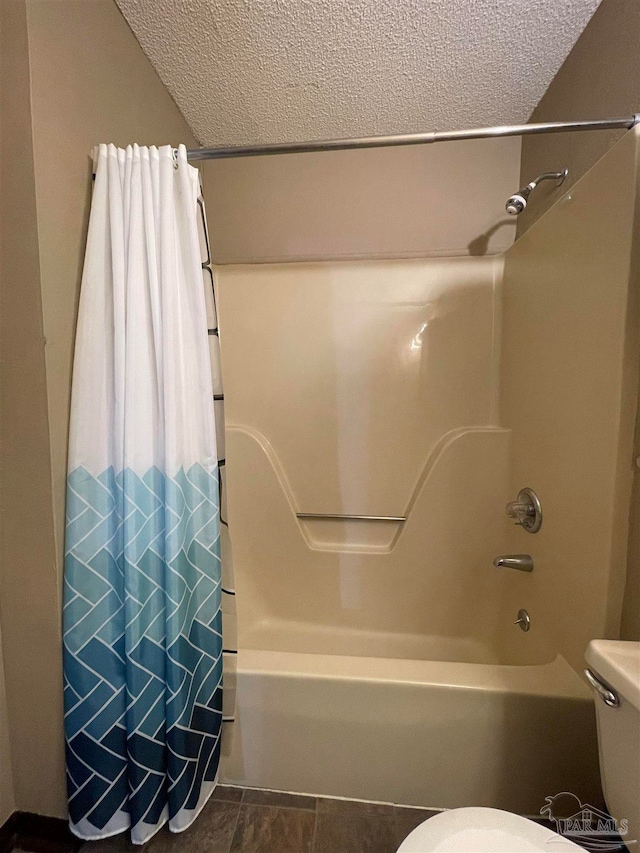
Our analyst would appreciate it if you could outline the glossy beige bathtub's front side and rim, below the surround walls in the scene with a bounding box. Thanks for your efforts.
[222,650,601,814]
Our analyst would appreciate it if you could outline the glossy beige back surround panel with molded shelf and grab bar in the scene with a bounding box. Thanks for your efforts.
[216,258,508,662]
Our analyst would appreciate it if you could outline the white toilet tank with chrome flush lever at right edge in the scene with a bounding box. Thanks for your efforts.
[585,640,640,850]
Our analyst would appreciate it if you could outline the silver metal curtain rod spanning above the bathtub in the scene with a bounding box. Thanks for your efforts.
[187,113,640,160]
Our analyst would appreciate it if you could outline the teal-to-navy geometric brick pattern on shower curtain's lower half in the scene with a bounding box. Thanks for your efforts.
[65,464,222,829]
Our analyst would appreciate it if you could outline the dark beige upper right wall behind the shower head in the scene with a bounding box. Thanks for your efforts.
[518,0,640,234]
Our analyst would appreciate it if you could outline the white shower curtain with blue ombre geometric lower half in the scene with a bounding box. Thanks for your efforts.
[64,145,222,844]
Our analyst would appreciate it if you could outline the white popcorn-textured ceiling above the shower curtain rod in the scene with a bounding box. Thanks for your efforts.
[117,0,599,145]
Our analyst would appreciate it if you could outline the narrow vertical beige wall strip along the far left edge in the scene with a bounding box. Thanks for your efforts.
[0,0,64,814]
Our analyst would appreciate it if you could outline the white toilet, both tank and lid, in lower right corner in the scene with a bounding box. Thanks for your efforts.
[398,640,640,853]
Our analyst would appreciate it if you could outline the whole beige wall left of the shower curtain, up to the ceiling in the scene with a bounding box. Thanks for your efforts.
[0,0,195,816]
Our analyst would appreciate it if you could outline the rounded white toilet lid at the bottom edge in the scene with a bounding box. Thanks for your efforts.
[398,808,584,853]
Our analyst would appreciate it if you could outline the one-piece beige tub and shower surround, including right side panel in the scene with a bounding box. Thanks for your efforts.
[210,126,638,813]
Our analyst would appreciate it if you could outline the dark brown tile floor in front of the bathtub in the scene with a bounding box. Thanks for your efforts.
[80,785,436,853]
